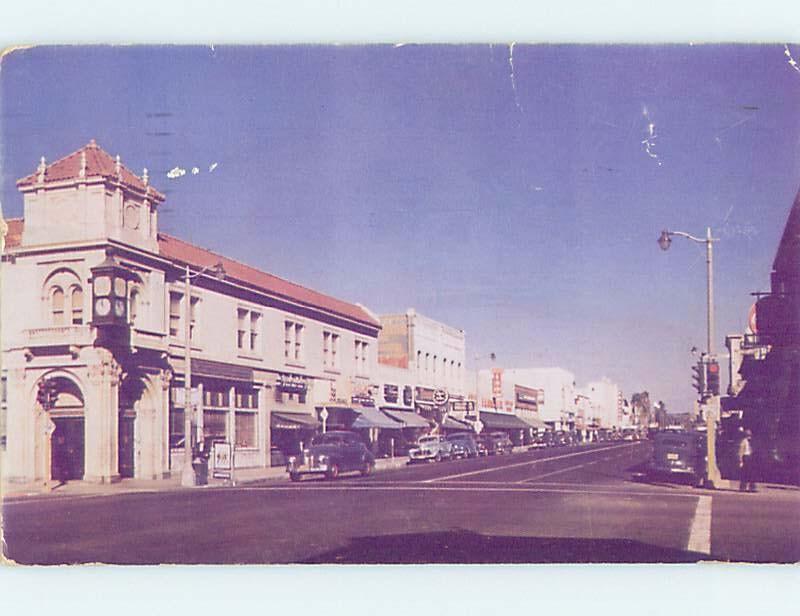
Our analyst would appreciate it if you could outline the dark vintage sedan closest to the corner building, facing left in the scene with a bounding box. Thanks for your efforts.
[286,430,375,481]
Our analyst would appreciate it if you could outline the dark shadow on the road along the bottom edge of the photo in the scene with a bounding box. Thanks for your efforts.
[299,530,709,564]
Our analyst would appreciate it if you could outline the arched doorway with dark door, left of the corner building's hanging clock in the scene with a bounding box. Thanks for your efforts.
[47,377,85,482]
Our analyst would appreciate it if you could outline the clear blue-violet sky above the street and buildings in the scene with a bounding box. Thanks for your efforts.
[0,45,800,411]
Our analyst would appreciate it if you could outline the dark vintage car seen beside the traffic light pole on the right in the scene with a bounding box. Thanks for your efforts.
[647,432,706,485]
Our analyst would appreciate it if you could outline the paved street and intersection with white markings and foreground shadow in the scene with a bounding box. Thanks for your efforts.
[4,442,800,564]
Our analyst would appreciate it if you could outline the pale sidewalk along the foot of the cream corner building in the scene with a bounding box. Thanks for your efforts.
[0,457,408,499]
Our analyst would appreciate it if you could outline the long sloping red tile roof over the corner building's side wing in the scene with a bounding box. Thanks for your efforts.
[158,233,380,328]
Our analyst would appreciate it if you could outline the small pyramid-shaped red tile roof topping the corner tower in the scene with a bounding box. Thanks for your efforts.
[17,139,164,201]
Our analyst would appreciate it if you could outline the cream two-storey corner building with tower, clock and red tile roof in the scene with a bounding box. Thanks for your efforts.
[1,141,380,482]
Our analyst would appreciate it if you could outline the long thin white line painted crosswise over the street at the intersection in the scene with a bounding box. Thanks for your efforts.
[231,482,697,498]
